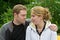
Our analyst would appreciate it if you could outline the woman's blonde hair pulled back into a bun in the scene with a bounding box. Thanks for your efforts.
[31,6,51,20]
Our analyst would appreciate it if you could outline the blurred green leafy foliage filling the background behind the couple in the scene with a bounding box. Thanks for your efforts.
[0,0,60,33]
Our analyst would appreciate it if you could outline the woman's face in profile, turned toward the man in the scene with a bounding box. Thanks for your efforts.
[31,13,43,25]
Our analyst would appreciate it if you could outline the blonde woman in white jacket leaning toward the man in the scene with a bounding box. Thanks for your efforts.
[26,6,57,40]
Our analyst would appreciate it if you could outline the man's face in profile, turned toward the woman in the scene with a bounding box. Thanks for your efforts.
[16,10,27,23]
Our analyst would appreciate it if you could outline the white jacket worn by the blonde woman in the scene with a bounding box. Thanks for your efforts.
[26,21,57,40]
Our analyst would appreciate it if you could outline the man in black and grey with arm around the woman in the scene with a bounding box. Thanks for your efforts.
[0,4,57,40]
